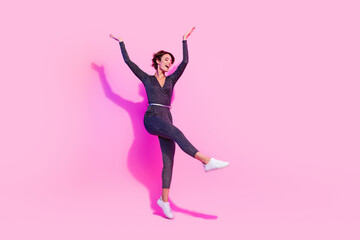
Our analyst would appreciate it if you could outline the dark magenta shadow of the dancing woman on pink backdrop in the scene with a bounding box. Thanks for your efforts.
[91,63,217,219]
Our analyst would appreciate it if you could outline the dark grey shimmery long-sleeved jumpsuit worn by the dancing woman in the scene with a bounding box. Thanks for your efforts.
[120,40,198,188]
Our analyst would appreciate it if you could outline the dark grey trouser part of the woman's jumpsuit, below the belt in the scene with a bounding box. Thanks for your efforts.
[144,113,198,188]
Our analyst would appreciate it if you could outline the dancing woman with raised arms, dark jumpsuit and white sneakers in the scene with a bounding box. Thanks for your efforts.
[110,27,229,219]
